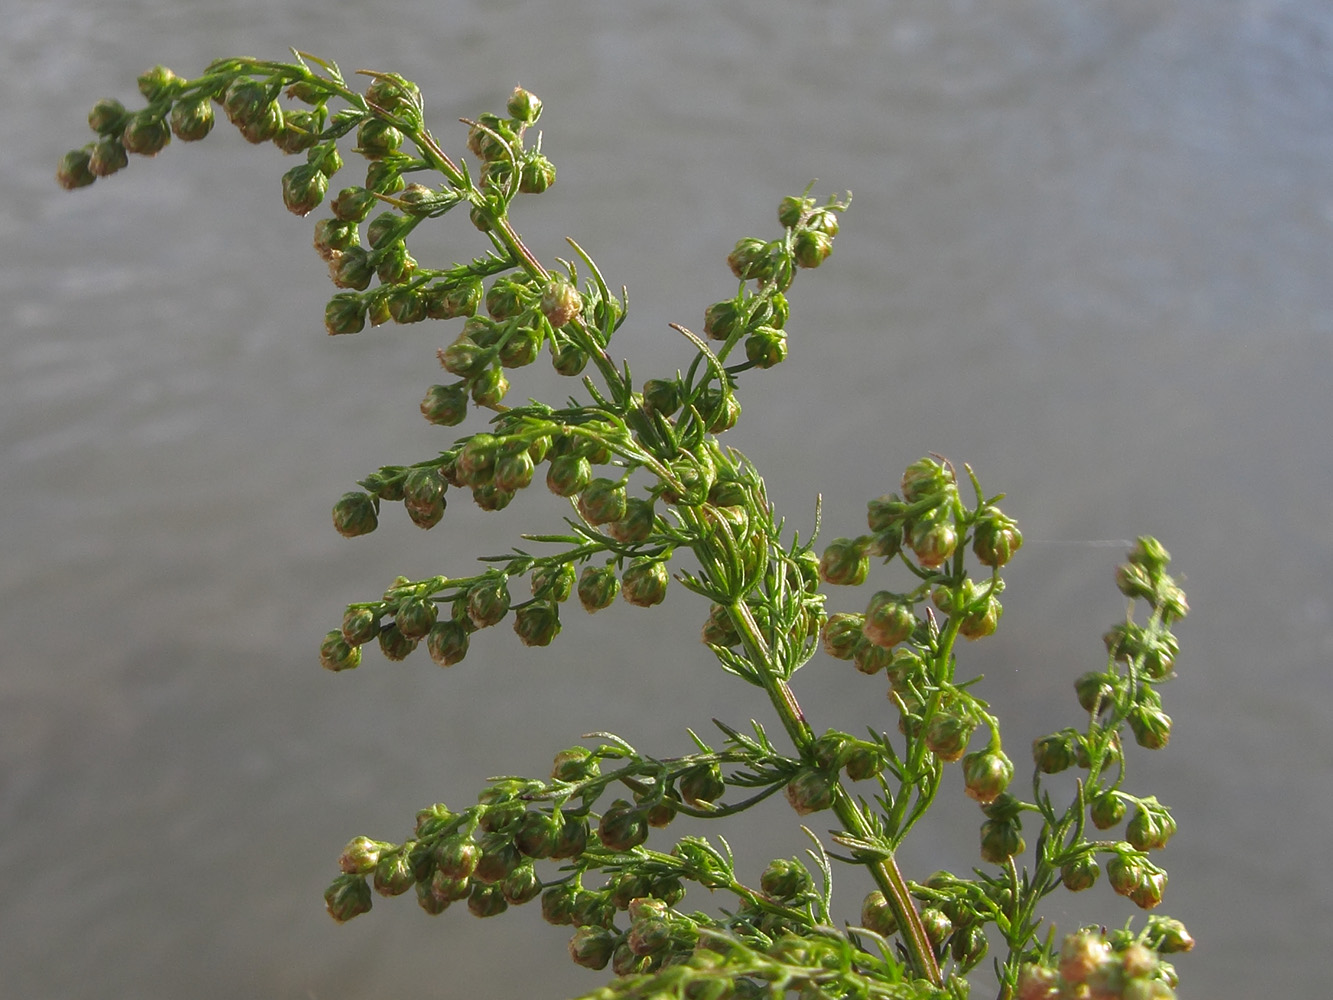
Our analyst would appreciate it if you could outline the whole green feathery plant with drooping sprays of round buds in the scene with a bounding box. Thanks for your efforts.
[57,55,1193,1000]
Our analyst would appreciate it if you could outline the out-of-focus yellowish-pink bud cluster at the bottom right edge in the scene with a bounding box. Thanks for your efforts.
[1013,917,1194,1000]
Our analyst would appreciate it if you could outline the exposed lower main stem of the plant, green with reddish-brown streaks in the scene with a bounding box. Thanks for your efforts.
[728,600,944,988]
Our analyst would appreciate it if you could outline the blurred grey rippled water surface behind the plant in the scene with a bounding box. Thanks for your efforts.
[0,0,1333,1000]
